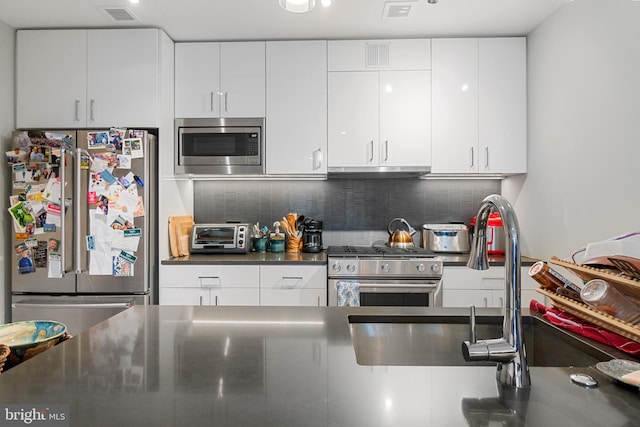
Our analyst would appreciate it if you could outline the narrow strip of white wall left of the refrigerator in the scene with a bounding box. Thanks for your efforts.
[0,21,15,323]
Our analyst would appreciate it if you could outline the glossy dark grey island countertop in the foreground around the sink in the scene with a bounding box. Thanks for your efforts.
[0,306,640,427]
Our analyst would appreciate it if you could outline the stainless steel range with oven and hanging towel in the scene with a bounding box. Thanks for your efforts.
[327,246,443,307]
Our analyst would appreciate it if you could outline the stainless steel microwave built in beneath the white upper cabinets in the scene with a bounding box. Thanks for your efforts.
[175,118,265,175]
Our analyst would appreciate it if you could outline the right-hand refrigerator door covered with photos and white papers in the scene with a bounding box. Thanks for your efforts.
[74,130,157,294]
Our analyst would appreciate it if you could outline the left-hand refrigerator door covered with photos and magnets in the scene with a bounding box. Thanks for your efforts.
[11,130,76,293]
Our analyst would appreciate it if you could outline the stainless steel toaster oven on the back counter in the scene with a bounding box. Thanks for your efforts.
[191,224,250,254]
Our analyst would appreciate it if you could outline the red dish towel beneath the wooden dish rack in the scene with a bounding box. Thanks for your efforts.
[529,300,640,357]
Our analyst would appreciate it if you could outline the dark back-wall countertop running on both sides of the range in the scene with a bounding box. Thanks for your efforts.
[161,251,537,266]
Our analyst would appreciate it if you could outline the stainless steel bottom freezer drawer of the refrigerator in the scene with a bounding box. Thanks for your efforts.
[11,295,149,335]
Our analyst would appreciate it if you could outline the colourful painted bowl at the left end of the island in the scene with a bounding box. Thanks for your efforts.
[0,320,67,368]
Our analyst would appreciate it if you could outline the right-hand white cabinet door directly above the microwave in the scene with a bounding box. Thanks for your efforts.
[220,42,265,117]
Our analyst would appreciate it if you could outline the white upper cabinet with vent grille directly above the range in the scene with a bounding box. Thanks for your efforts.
[328,39,431,172]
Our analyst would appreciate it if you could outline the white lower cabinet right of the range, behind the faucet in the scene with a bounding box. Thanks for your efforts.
[442,266,545,308]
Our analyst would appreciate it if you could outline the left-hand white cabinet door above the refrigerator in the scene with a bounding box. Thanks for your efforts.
[16,30,87,129]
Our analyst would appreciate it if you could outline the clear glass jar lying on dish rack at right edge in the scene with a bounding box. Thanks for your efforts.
[580,279,640,325]
